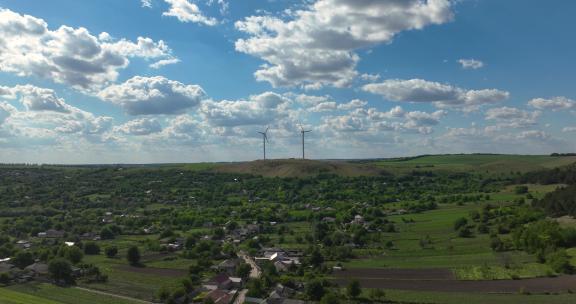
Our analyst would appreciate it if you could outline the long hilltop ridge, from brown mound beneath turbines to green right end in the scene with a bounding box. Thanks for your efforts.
[210,154,576,177]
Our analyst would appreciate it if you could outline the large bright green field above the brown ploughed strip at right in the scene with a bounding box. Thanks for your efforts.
[344,186,555,272]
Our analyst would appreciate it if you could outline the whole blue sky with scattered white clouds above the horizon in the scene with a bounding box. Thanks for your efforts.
[0,0,576,163]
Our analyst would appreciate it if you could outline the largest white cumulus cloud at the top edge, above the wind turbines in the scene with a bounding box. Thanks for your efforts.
[236,0,453,89]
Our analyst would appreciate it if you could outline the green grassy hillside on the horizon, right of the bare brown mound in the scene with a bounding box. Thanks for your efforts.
[371,154,576,173]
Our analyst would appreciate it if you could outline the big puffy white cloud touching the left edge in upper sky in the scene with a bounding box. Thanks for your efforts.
[0,9,172,91]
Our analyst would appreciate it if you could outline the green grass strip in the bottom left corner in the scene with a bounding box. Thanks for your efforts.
[6,283,140,304]
